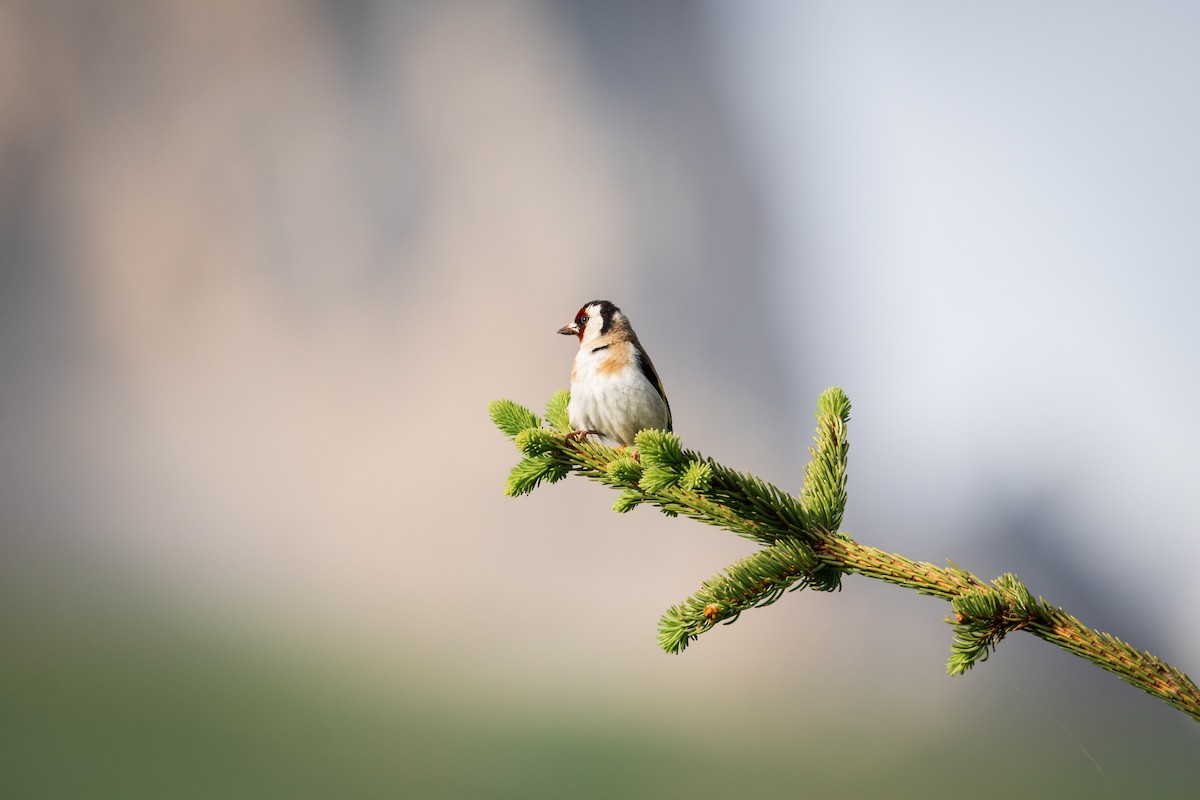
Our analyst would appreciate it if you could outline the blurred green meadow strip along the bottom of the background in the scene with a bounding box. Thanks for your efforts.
[0,551,1198,799]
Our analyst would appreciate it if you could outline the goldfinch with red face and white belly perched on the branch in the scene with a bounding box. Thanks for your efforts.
[558,300,671,446]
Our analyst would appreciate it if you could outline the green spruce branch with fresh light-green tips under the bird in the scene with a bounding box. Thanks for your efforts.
[488,387,1200,721]
